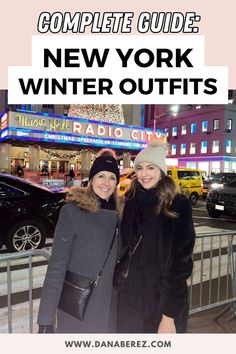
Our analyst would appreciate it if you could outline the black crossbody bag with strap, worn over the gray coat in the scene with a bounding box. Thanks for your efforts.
[58,228,117,321]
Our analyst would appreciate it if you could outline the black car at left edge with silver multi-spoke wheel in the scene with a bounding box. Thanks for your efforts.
[0,173,66,252]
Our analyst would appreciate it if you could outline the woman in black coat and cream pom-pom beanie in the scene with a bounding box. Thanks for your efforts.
[118,141,195,333]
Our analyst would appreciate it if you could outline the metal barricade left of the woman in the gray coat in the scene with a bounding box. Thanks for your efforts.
[0,250,50,333]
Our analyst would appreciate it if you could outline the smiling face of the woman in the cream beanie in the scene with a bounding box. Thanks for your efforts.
[135,162,161,189]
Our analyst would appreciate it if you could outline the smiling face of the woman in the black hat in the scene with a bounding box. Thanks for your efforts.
[91,171,117,200]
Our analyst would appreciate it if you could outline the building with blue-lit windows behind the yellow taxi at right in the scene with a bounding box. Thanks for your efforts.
[145,104,236,175]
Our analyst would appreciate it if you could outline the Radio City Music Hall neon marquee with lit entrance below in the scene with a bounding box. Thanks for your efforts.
[0,109,166,178]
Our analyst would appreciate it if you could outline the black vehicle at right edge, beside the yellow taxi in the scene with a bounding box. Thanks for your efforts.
[206,179,236,218]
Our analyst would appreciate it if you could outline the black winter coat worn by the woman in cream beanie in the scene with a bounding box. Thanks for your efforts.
[118,194,195,332]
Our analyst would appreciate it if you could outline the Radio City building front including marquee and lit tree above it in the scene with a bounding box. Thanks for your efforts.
[0,90,147,177]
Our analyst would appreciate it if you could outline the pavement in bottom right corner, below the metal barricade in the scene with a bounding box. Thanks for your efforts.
[187,306,236,333]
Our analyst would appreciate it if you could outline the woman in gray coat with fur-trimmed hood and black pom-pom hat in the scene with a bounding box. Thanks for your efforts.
[38,149,120,333]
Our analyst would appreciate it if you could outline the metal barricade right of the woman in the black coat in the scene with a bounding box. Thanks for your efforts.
[189,232,236,315]
